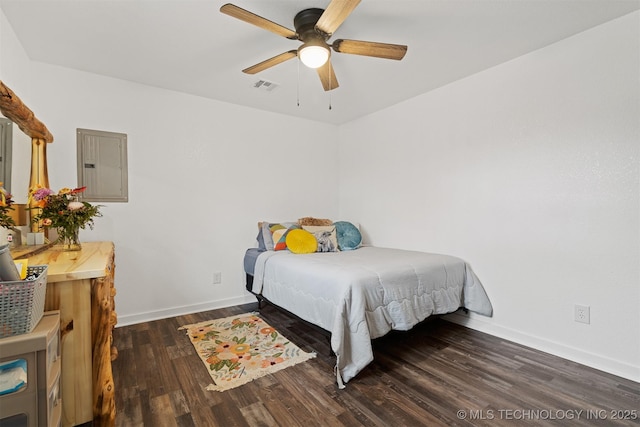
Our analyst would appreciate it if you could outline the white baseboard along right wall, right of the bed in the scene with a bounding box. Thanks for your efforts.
[443,313,640,382]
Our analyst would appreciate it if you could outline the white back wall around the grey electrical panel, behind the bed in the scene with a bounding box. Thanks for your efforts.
[0,8,338,326]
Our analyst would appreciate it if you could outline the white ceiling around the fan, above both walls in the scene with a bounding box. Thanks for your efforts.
[0,0,640,124]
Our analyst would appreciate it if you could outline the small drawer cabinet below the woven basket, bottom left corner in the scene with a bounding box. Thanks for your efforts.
[0,311,62,427]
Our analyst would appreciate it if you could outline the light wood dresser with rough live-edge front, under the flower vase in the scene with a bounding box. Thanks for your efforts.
[29,242,117,426]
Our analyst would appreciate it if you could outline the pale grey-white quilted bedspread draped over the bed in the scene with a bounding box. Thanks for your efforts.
[252,247,493,388]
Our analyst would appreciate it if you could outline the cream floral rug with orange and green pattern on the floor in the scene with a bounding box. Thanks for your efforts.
[180,313,316,391]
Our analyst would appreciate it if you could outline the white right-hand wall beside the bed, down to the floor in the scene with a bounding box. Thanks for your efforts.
[339,12,640,380]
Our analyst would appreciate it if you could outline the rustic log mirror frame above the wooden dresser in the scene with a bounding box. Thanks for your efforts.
[0,80,53,231]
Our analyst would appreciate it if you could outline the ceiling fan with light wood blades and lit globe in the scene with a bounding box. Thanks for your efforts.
[220,0,407,91]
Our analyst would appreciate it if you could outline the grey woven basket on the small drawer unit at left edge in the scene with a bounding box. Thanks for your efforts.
[0,265,47,338]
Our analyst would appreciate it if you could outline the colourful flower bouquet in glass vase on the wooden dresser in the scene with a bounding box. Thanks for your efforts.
[29,186,102,250]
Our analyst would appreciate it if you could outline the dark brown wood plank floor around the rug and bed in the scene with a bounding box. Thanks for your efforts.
[113,304,640,427]
